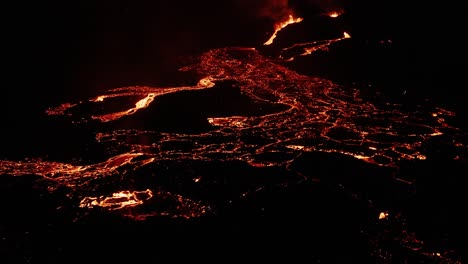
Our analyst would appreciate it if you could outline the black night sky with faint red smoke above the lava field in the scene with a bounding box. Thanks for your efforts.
[4,0,466,107]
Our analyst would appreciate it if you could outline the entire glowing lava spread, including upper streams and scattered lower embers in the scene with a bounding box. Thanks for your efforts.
[0,7,468,262]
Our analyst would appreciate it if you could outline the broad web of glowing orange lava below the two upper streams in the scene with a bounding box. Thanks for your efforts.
[0,42,467,223]
